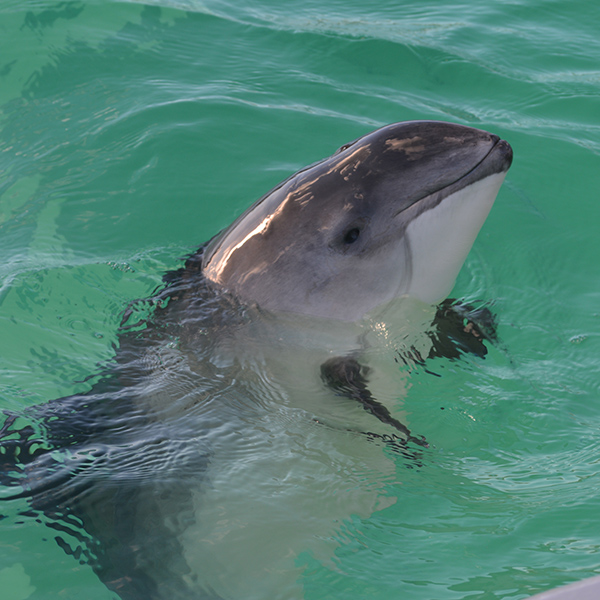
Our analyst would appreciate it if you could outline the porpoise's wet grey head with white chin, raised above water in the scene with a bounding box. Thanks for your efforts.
[203,121,512,321]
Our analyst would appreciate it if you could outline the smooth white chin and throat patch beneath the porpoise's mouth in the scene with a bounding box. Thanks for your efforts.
[406,173,506,304]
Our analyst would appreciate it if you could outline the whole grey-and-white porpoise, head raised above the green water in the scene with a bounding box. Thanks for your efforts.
[0,121,512,600]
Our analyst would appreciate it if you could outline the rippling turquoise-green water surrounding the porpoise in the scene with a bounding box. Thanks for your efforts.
[0,0,600,600]
